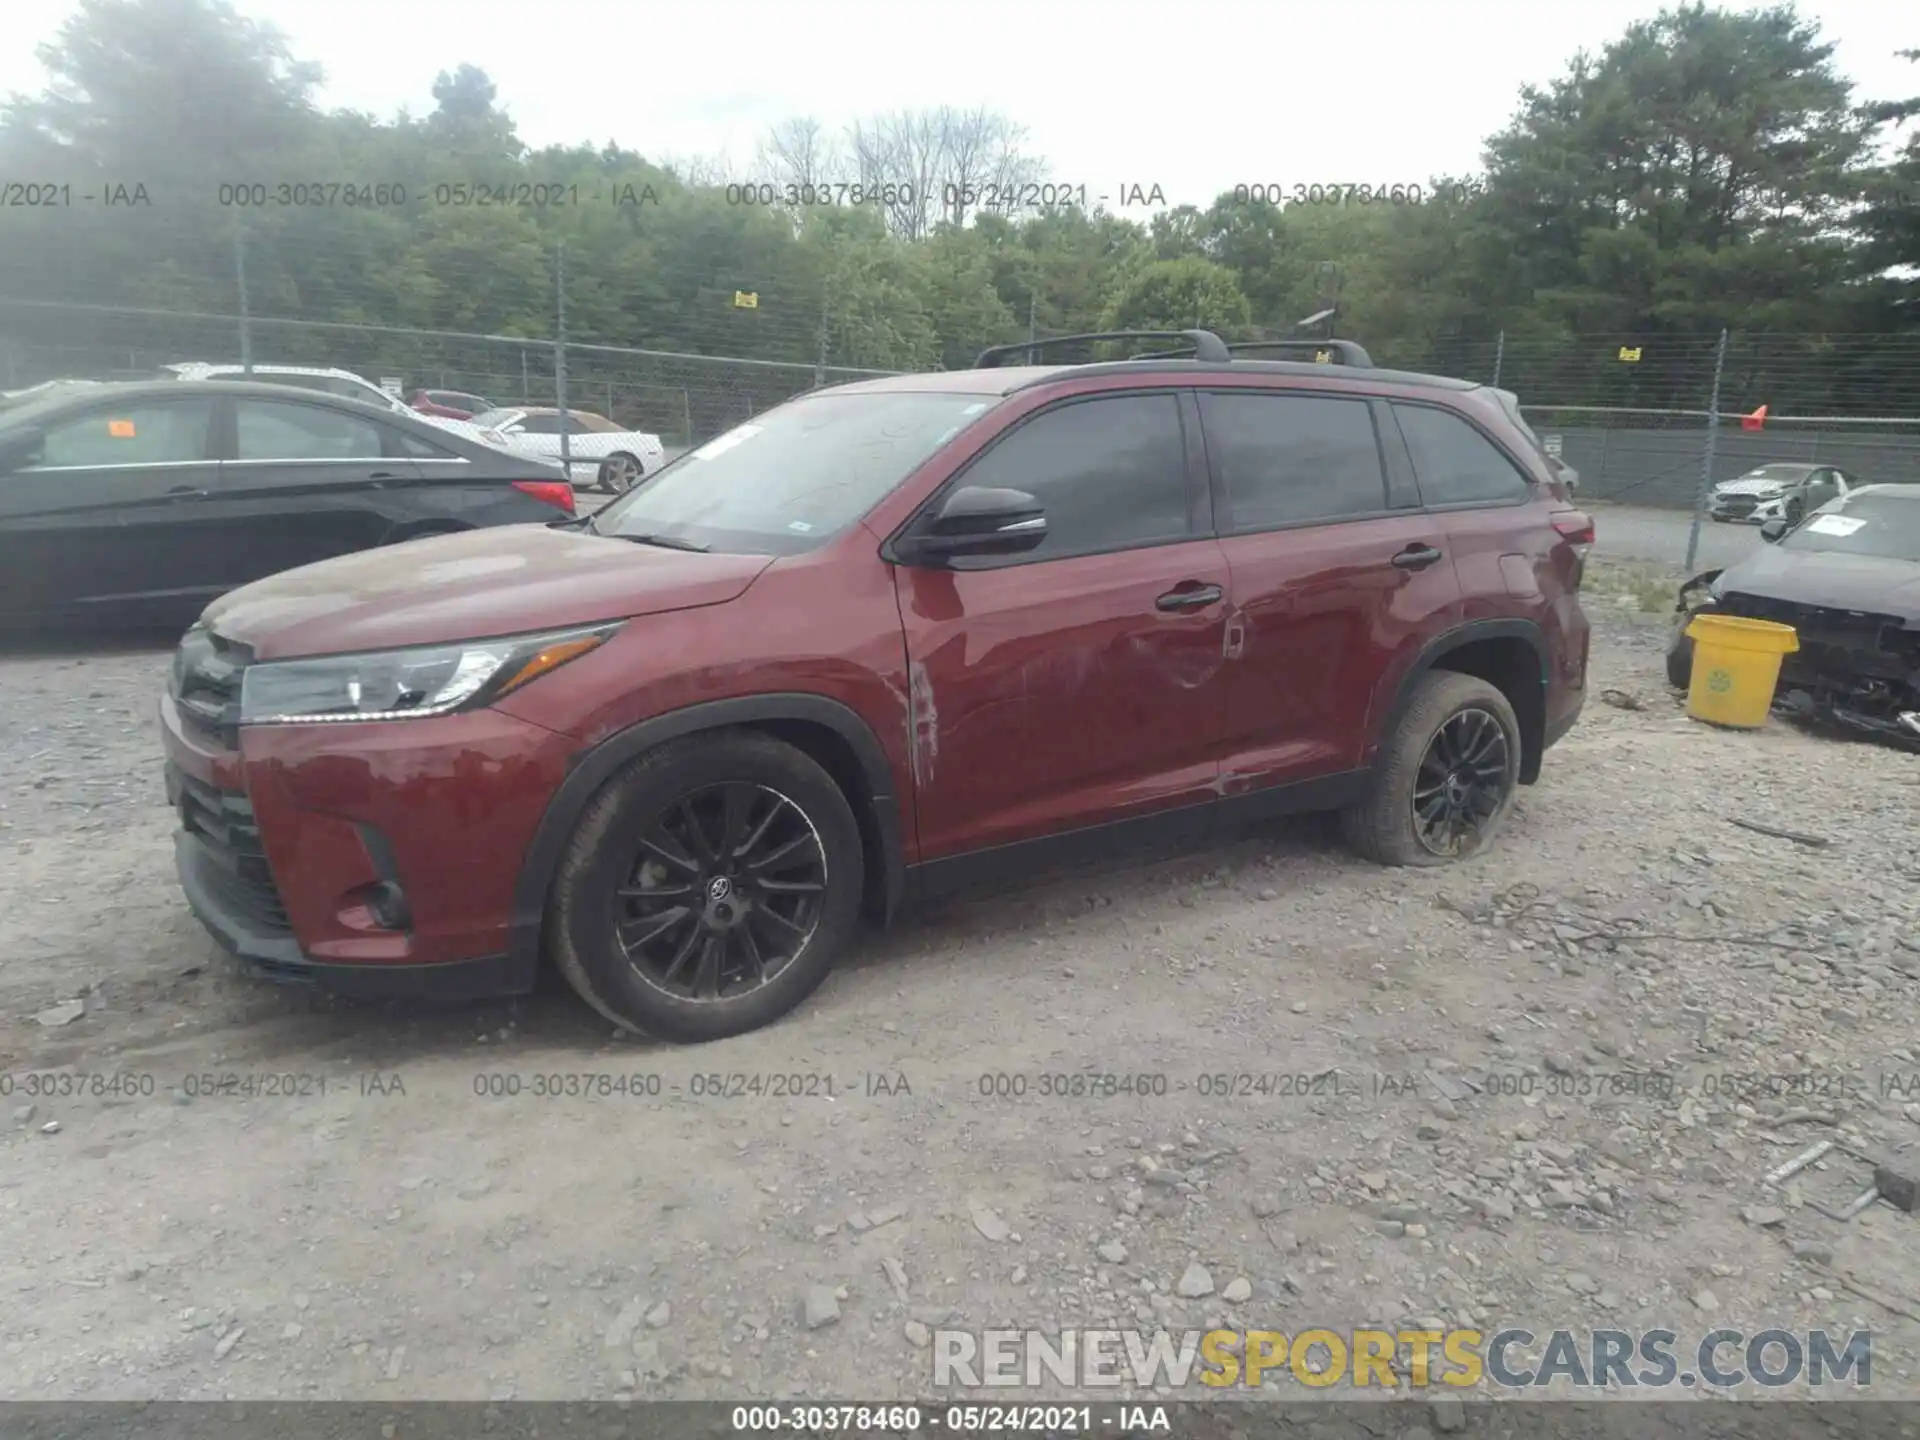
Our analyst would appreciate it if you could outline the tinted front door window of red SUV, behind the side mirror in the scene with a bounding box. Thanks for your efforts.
[960,396,1188,566]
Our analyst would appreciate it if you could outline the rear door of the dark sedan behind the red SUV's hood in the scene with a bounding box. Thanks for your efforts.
[213,396,420,589]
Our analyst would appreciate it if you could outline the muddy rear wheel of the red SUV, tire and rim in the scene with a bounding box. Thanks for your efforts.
[1340,670,1521,866]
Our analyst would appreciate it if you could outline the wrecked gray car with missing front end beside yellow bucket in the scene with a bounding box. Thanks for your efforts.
[1667,486,1920,751]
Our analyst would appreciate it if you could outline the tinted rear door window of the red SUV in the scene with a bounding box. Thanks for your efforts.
[1200,392,1386,530]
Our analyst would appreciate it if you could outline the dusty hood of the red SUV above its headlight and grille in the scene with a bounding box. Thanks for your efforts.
[202,524,774,660]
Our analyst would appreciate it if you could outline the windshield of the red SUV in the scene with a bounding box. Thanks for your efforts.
[593,390,998,555]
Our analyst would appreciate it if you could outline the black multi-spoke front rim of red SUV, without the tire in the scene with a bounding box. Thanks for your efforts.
[612,781,828,1000]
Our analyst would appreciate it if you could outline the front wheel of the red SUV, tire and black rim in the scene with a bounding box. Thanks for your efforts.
[547,730,864,1044]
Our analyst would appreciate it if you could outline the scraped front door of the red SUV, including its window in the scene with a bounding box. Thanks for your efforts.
[895,390,1227,860]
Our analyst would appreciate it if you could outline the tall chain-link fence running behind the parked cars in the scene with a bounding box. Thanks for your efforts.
[0,225,1920,545]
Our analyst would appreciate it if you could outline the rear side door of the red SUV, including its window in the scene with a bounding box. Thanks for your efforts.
[1200,388,1459,797]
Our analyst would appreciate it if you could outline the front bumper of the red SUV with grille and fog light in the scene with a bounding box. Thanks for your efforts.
[159,695,574,998]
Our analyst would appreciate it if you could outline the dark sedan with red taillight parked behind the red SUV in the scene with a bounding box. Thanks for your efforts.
[0,380,574,630]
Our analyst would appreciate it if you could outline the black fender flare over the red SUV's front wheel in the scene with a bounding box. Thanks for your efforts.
[507,691,906,973]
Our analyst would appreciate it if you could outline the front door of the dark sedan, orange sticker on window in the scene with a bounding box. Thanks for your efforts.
[0,396,217,622]
